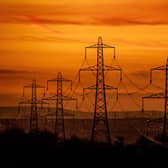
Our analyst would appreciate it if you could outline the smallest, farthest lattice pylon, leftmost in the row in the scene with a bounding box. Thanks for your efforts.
[19,80,45,132]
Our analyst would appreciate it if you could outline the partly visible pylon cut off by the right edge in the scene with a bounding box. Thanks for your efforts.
[142,57,168,140]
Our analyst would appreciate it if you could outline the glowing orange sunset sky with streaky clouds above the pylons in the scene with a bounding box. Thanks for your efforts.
[0,0,168,112]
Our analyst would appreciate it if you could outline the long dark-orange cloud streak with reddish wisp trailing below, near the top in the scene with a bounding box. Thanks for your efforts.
[0,15,168,26]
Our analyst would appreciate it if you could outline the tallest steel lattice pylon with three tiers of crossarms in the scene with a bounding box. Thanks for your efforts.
[79,37,122,143]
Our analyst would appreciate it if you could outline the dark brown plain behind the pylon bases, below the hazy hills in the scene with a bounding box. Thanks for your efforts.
[0,118,150,144]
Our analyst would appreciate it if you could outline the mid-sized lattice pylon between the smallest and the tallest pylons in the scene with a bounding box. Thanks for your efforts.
[43,72,77,141]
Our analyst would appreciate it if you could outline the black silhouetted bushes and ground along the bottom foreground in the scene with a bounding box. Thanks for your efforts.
[0,130,168,167]
